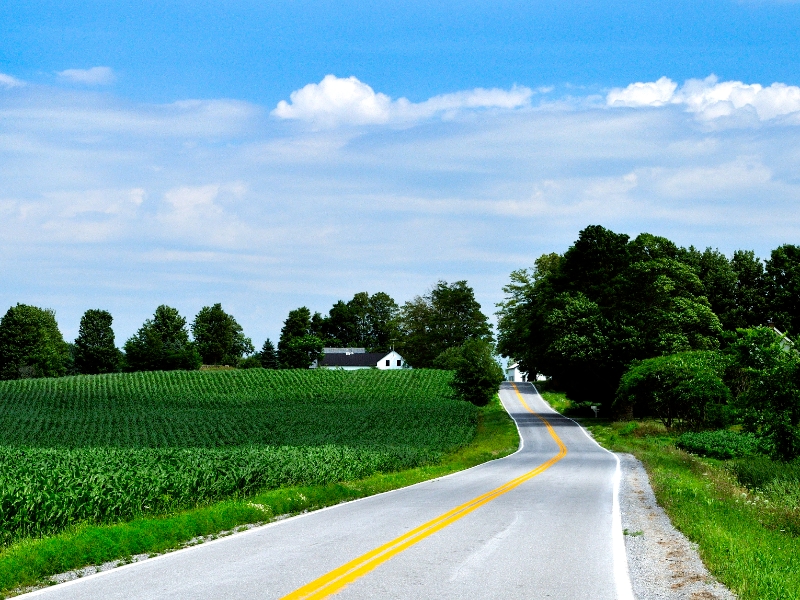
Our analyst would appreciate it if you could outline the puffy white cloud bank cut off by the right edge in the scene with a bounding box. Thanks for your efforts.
[606,75,800,121]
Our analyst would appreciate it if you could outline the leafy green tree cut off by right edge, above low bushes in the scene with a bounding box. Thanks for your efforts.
[727,327,800,460]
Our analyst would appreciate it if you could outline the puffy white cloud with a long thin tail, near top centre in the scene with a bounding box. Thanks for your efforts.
[272,75,533,127]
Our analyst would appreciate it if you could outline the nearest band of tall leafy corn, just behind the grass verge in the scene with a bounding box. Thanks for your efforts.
[0,445,438,544]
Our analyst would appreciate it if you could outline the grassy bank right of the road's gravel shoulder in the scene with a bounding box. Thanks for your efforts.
[542,392,800,600]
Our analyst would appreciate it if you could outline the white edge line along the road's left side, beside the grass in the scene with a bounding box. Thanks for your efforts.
[15,389,538,598]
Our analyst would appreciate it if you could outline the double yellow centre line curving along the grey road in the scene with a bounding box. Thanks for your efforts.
[282,383,567,600]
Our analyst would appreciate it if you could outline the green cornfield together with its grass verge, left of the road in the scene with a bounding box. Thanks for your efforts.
[0,370,519,591]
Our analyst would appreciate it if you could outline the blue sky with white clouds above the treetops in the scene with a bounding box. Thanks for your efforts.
[0,0,800,346]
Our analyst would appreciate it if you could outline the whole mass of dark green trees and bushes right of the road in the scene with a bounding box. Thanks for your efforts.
[498,225,800,457]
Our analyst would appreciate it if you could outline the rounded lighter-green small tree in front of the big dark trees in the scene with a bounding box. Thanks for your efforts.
[614,351,730,429]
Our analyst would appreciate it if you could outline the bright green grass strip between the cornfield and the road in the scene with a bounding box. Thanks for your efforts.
[0,396,519,597]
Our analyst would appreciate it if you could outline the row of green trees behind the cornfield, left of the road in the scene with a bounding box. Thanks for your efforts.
[0,281,502,403]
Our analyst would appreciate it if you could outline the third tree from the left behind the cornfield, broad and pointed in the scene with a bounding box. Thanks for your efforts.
[125,304,202,371]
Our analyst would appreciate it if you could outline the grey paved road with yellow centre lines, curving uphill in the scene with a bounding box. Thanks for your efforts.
[24,383,632,600]
